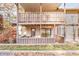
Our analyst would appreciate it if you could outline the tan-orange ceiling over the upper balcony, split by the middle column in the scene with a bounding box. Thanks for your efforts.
[20,3,61,12]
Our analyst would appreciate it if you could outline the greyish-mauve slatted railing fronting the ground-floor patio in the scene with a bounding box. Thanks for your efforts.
[16,38,55,44]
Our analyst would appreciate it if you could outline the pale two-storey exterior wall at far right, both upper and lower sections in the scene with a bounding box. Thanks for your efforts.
[65,14,78,42]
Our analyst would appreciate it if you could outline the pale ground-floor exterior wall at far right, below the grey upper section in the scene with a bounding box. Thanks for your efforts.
[65,26,79,42]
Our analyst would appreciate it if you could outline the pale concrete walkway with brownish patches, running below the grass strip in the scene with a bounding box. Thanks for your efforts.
[0,50,79,56]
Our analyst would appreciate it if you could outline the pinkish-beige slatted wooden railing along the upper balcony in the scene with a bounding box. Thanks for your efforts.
[18,13,64,24]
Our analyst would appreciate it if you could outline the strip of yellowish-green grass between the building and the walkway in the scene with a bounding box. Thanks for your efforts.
[0,44,79,50]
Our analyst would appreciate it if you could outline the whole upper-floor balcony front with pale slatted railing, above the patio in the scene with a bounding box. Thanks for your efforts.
[18,12,64,24]
